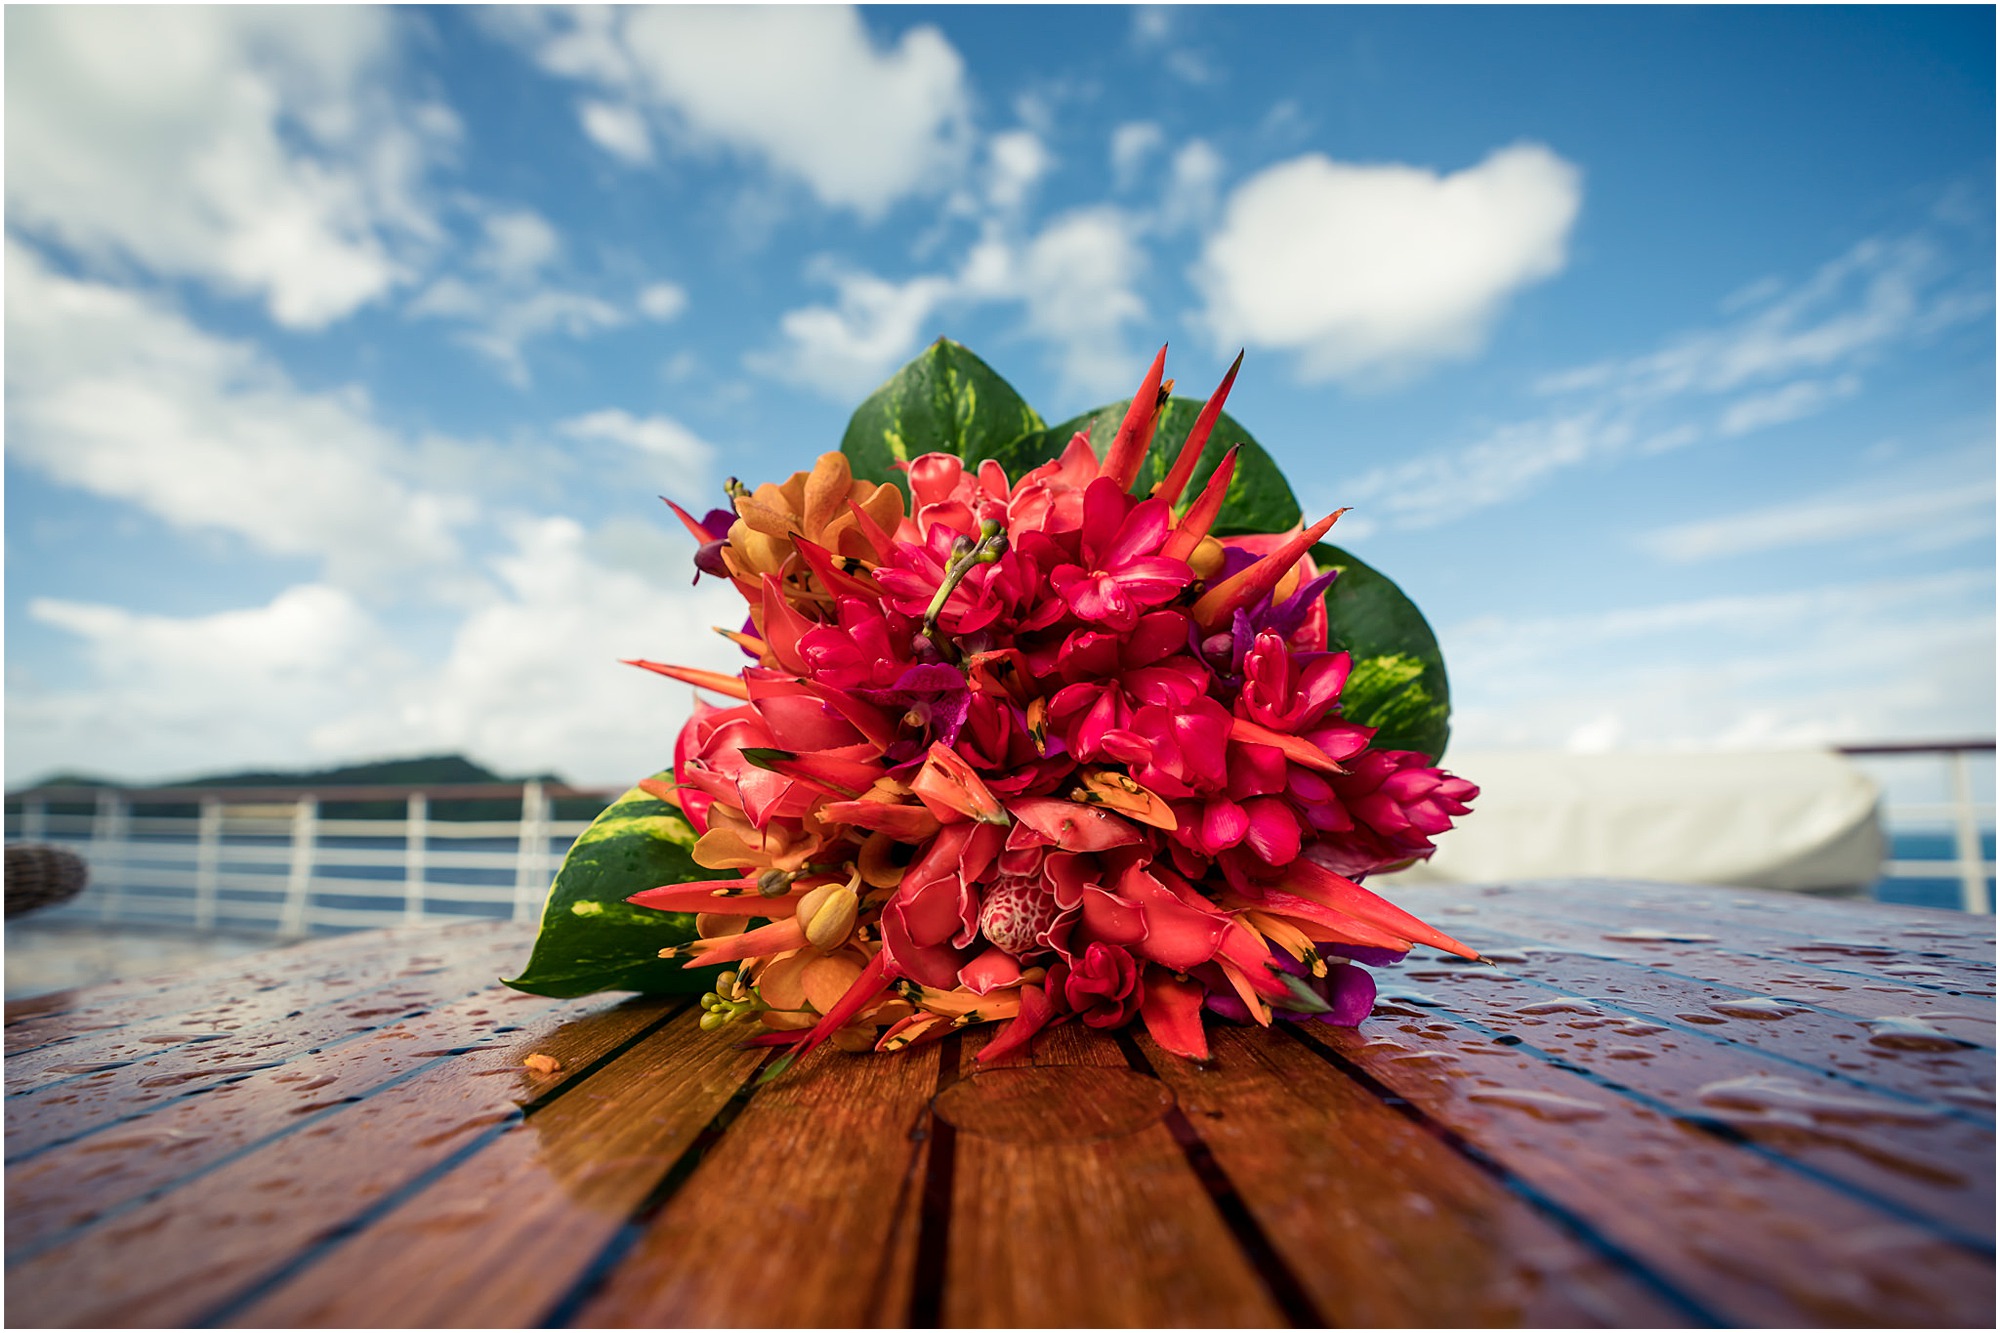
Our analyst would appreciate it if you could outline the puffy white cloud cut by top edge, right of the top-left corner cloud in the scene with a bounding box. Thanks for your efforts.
[490,6,970,218]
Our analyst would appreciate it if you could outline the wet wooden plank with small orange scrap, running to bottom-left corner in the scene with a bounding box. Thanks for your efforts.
[6,980,670,1327]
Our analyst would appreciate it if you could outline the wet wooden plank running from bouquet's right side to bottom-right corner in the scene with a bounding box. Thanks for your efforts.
[1306,1005,1994,1327]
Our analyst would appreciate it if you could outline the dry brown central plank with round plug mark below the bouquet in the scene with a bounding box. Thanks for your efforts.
[938,1023,1280,1327]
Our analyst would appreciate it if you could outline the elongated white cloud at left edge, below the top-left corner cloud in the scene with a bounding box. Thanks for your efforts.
[6,242,470,582]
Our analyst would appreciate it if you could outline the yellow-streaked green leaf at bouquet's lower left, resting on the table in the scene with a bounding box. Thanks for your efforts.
[506,773,716,999]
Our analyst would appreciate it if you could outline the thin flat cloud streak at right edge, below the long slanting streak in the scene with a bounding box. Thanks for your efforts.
[1638,462,1994,564]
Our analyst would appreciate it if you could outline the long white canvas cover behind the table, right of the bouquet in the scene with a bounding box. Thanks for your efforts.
[1388,751,1882,895]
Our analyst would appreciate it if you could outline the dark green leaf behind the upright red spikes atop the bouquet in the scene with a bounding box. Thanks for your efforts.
[1008,398,1300,536]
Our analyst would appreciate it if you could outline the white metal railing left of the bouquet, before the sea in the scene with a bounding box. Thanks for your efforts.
[6,783,616,939]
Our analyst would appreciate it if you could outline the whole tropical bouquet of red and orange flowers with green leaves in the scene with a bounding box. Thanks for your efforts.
[508,340,1478,1067]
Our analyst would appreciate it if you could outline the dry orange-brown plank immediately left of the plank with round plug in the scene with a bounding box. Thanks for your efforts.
[560,1024,938,1327]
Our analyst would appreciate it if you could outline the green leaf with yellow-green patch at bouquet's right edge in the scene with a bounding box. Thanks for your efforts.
[1312,546,1452,763]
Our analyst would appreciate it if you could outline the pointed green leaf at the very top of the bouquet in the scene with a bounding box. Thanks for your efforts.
[840,338,1042,494]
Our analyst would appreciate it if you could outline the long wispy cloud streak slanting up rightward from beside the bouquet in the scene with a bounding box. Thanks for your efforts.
[1338,226,1990,528]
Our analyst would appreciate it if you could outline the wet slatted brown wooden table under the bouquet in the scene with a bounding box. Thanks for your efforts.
[6,883,1994,1327]
